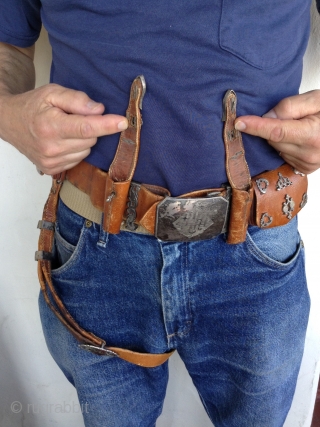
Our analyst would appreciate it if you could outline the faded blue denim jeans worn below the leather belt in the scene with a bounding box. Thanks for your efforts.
[40,201,309,427]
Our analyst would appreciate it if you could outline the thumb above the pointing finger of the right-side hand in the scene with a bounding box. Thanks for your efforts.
[262,90,320,120]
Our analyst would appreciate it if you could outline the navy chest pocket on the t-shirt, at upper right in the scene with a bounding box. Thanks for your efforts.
[219,0,310,70]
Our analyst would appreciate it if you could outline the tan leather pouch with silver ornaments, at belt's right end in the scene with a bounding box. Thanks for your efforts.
[249,163,308,228]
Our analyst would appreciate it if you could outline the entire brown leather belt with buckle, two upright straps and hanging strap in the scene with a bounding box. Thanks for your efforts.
[36,76,307,367]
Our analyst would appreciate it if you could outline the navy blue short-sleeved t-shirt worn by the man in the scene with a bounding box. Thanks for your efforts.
[0,0,310,195]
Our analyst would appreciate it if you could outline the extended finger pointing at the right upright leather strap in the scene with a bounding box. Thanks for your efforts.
[235,116,320,147]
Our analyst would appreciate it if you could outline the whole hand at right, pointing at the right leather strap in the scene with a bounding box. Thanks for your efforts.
[235,90,320,174]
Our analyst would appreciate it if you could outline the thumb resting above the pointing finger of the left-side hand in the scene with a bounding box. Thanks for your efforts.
[46,84,104,115]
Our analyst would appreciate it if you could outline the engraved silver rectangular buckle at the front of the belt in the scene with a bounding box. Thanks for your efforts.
[155,191,230,242]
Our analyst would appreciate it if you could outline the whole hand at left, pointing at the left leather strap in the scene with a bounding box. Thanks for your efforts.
[0,84,128,175]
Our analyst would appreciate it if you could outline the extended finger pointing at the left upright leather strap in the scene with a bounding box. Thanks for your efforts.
[52,111,128,139]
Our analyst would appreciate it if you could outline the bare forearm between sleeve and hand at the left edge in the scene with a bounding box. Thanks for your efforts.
[0,43,35,97]
